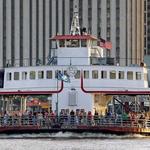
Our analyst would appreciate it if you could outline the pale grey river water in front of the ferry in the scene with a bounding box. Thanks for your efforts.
[0,133,150,150]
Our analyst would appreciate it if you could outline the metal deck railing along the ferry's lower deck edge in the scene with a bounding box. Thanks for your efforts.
[0,115,150,129]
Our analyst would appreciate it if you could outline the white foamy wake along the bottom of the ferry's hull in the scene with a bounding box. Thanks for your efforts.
[0,132,150,140]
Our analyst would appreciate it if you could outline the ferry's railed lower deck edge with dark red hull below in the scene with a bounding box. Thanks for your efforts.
[0,115,150,135]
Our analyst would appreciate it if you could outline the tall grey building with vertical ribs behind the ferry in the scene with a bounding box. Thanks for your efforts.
[0,0,144,67]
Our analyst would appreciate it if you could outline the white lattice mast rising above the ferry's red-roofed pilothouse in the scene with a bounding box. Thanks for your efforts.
[70,0,81,35]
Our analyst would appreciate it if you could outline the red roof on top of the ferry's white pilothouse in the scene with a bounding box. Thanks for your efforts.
[50,34,97,40]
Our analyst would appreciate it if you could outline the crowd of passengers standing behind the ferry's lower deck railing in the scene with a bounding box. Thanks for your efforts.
[0,110,150,127]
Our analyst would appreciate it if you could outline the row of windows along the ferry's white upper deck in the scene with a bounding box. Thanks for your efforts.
[7,70,147,81]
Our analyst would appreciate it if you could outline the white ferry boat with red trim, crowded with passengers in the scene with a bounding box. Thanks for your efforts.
[0,1,150,134]
